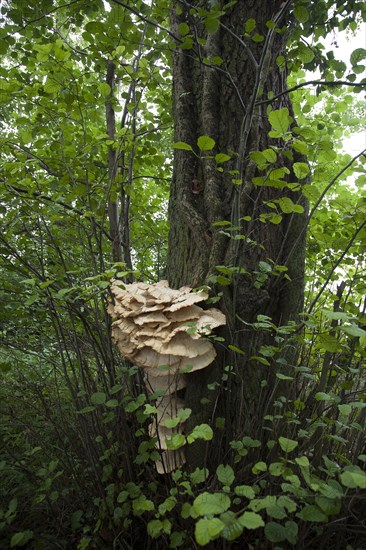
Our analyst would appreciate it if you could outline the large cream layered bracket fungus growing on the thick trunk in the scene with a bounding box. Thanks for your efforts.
[108,280,226,473]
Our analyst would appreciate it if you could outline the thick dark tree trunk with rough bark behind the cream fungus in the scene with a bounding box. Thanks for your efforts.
[167,0,306,468]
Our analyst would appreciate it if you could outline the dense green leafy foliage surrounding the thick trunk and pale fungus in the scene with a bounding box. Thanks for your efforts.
[0,0,366,550]
